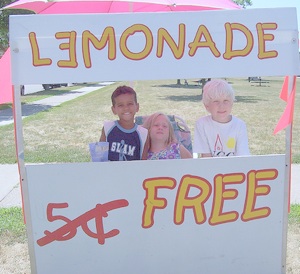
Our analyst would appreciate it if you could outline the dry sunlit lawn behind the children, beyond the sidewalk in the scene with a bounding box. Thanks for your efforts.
[0,77,300,164]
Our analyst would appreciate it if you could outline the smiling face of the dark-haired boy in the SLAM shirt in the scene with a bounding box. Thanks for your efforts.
[111,94,139,121]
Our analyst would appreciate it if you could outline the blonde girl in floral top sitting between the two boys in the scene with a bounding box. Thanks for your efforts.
[143,112,192,160]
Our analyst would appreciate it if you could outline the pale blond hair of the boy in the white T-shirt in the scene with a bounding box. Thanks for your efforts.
[202,79,235,105]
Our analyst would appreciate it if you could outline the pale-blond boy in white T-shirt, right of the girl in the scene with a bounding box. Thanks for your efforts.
[193,79,250,157]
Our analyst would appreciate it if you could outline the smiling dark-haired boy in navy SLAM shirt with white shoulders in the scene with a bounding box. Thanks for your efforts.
[100,86,148,161]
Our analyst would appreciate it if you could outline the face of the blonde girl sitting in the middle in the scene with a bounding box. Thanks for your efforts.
[150,115,170,142]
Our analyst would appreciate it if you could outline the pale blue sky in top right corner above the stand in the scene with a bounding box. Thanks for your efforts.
[247,0,300,30]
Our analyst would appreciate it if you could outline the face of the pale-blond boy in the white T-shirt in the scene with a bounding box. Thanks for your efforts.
[205,97,233,123]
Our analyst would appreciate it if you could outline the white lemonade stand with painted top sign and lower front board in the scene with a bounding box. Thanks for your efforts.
[10,8,299,274]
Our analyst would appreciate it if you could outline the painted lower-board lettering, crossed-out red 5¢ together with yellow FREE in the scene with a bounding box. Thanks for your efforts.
[37,169,278,246]
